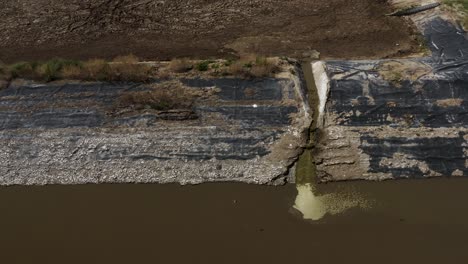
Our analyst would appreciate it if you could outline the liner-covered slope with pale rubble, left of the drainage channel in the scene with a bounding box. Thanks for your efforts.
[0,69,310,185]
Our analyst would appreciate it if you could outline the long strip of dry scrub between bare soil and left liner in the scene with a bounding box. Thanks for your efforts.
[0,55,283,87]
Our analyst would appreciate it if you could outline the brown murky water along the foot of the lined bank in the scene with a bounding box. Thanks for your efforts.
[0,179,468,264]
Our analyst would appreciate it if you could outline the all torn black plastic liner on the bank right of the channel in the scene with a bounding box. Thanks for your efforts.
[324,18,468,178]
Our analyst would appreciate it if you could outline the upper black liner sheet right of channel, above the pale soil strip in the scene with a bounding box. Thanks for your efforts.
[327,18,468,127]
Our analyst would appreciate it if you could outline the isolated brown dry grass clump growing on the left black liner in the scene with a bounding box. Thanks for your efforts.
[117,84,196,111]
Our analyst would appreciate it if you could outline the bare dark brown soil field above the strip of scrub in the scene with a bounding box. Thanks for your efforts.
[0,0,419,62]
